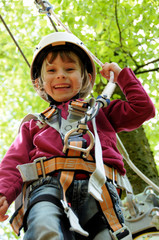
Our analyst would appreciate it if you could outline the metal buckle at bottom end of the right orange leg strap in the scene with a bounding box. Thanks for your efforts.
[110,224,132,240]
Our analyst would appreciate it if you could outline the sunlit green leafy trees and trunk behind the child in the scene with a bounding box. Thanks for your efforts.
[0,0,159,240]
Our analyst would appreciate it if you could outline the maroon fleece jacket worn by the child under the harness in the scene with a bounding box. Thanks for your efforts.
[0,68,155,204]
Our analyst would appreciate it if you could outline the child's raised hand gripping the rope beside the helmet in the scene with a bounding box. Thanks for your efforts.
[100,63,122,82]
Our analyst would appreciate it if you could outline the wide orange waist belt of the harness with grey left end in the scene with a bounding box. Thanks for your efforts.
[17,155,118,184]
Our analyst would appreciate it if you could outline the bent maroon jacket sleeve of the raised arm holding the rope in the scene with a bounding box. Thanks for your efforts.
[103,68,155,132]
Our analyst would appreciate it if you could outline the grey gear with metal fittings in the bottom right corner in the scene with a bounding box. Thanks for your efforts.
[122,186,159,237]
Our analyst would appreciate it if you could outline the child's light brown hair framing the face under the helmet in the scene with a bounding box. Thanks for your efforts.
[36,50,93,100]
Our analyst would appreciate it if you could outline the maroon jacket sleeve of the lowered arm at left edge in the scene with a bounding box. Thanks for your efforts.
[0,122,33,204]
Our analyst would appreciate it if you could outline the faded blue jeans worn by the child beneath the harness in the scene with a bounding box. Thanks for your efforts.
[23,177,123,240]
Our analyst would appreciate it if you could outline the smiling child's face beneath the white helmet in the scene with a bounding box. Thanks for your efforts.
[43,53,82,102]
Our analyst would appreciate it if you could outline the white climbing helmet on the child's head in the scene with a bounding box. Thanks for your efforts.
[31,32,96,101]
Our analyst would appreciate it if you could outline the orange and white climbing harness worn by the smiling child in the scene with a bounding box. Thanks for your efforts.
[11,96,132,240]
